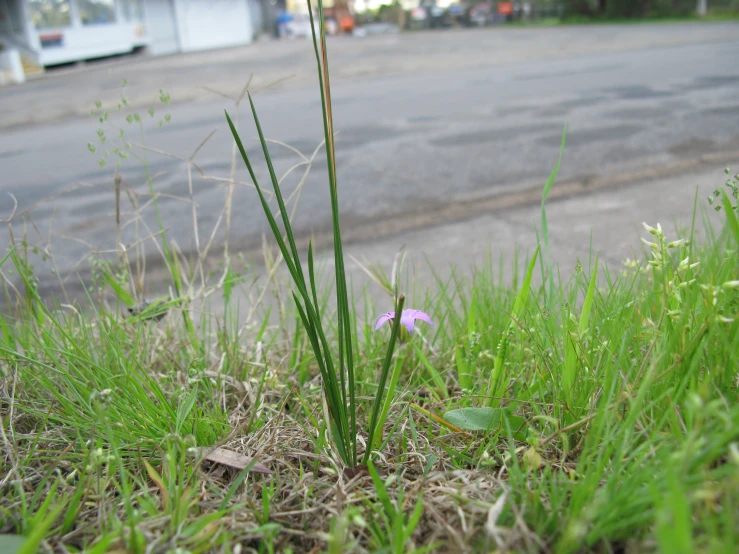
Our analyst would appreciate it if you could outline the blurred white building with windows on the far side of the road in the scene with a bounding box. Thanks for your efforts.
[0,0,268,78]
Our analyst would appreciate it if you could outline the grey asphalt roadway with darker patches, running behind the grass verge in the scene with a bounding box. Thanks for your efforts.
[0,26,739,294]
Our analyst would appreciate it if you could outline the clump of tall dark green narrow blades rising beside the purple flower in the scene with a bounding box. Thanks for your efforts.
[226,0,404,467]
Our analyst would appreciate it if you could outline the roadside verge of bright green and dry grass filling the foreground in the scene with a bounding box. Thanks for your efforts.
[0,2,739,554]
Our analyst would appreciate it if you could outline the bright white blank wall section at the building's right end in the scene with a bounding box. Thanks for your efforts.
[175,0,254,52]
